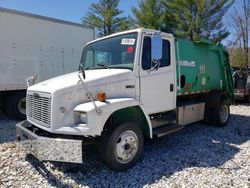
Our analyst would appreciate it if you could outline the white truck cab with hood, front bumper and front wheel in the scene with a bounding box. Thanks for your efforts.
[17,28,232,171]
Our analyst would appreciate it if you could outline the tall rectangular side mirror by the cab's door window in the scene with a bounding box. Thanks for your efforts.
[151,35,162,63]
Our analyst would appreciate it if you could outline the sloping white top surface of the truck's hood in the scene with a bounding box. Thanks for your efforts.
[28,69,133,93]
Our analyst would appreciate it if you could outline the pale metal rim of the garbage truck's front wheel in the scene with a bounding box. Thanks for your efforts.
[115,131,139,163]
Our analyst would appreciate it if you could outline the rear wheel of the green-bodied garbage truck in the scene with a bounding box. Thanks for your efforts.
[212,100,230,127]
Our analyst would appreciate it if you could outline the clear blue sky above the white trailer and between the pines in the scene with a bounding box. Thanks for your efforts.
[0,0,138,23]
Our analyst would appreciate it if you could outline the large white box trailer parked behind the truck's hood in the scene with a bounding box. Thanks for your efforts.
[0,7,95,119]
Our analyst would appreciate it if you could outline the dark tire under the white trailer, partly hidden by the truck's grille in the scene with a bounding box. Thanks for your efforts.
[5,91,26,120]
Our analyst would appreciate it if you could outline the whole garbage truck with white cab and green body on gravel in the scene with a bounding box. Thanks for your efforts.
[16,28,234,171]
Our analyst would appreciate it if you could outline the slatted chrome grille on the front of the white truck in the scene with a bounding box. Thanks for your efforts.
[27,93,51,127]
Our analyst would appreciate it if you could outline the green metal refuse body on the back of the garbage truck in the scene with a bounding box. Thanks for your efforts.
[176,39,233,98]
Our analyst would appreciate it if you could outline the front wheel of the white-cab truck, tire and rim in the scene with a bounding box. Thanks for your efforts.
[99,123,144,171]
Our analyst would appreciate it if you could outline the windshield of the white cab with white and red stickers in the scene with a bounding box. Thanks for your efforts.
[81,33,137,70]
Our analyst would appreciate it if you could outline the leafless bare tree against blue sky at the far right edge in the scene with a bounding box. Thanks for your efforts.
[230,0,250,65]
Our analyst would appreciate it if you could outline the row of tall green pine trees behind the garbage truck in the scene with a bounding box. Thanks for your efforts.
[82,0,250,65]
